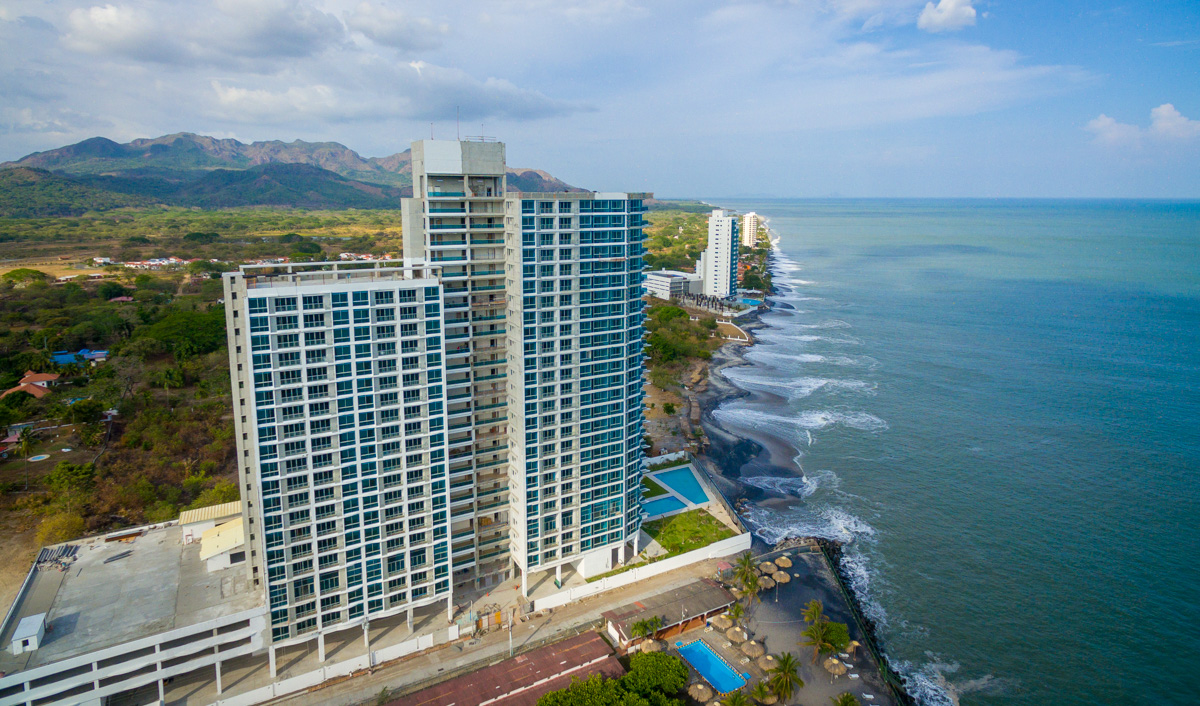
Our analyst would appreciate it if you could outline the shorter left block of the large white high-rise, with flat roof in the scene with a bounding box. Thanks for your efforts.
[224,261,452,644]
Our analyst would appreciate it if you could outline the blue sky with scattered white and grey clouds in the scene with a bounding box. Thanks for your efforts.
[0,0,1200,198]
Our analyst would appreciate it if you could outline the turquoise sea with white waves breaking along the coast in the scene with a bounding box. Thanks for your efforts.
[715,199,1200,705]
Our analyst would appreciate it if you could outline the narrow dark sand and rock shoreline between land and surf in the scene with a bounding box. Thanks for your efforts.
[684,250,917,706]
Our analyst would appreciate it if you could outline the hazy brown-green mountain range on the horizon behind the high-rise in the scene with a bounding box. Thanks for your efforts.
[0,132,581,217]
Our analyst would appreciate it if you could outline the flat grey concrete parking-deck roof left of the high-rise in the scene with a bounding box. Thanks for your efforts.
[0,525,263,675]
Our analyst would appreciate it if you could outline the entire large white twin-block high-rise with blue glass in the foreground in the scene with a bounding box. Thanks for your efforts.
[224,140,647,657]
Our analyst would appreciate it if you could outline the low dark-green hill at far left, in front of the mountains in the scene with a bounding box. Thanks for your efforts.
[0,167,157,219]
